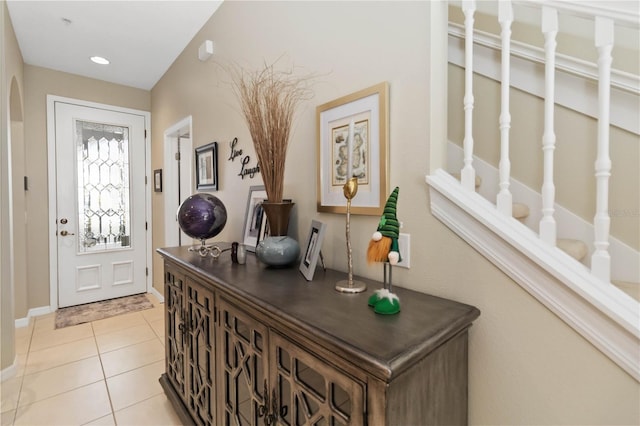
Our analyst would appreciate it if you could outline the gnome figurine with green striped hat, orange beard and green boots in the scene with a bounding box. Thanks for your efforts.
[367,187,402,315]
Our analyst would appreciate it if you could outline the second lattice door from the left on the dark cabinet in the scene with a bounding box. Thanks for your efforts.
[185,277,216,425]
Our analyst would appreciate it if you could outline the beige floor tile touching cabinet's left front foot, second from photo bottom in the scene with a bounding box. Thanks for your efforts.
[107,361,164,412]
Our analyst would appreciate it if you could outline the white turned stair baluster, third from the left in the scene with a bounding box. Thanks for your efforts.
[540,7,558,246]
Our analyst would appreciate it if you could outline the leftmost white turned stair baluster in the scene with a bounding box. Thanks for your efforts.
[461,0,476,191]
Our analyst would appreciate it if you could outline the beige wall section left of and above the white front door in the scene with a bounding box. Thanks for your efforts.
[18,65,151,316]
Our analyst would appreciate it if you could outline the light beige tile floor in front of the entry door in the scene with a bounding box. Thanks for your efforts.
[0,295,181,426]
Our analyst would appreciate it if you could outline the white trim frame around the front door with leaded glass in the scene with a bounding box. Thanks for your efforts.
[47,95,153,312]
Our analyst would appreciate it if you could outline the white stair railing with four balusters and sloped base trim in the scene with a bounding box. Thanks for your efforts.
[426,0,640,382]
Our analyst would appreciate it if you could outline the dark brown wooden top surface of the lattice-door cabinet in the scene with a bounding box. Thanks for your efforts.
[157,243,480,379]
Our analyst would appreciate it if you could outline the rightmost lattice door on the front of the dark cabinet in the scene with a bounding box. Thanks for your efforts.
[269,330,365,426]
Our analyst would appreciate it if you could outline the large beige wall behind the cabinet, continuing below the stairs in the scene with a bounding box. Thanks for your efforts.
[151,1,640,425]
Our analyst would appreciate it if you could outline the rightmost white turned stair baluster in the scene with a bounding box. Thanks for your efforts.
[591,18,613,282]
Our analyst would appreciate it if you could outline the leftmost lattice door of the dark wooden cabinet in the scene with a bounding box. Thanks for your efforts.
[164,264,187,399]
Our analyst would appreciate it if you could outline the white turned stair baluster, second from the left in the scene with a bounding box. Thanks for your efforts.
[496,0,513,217]
